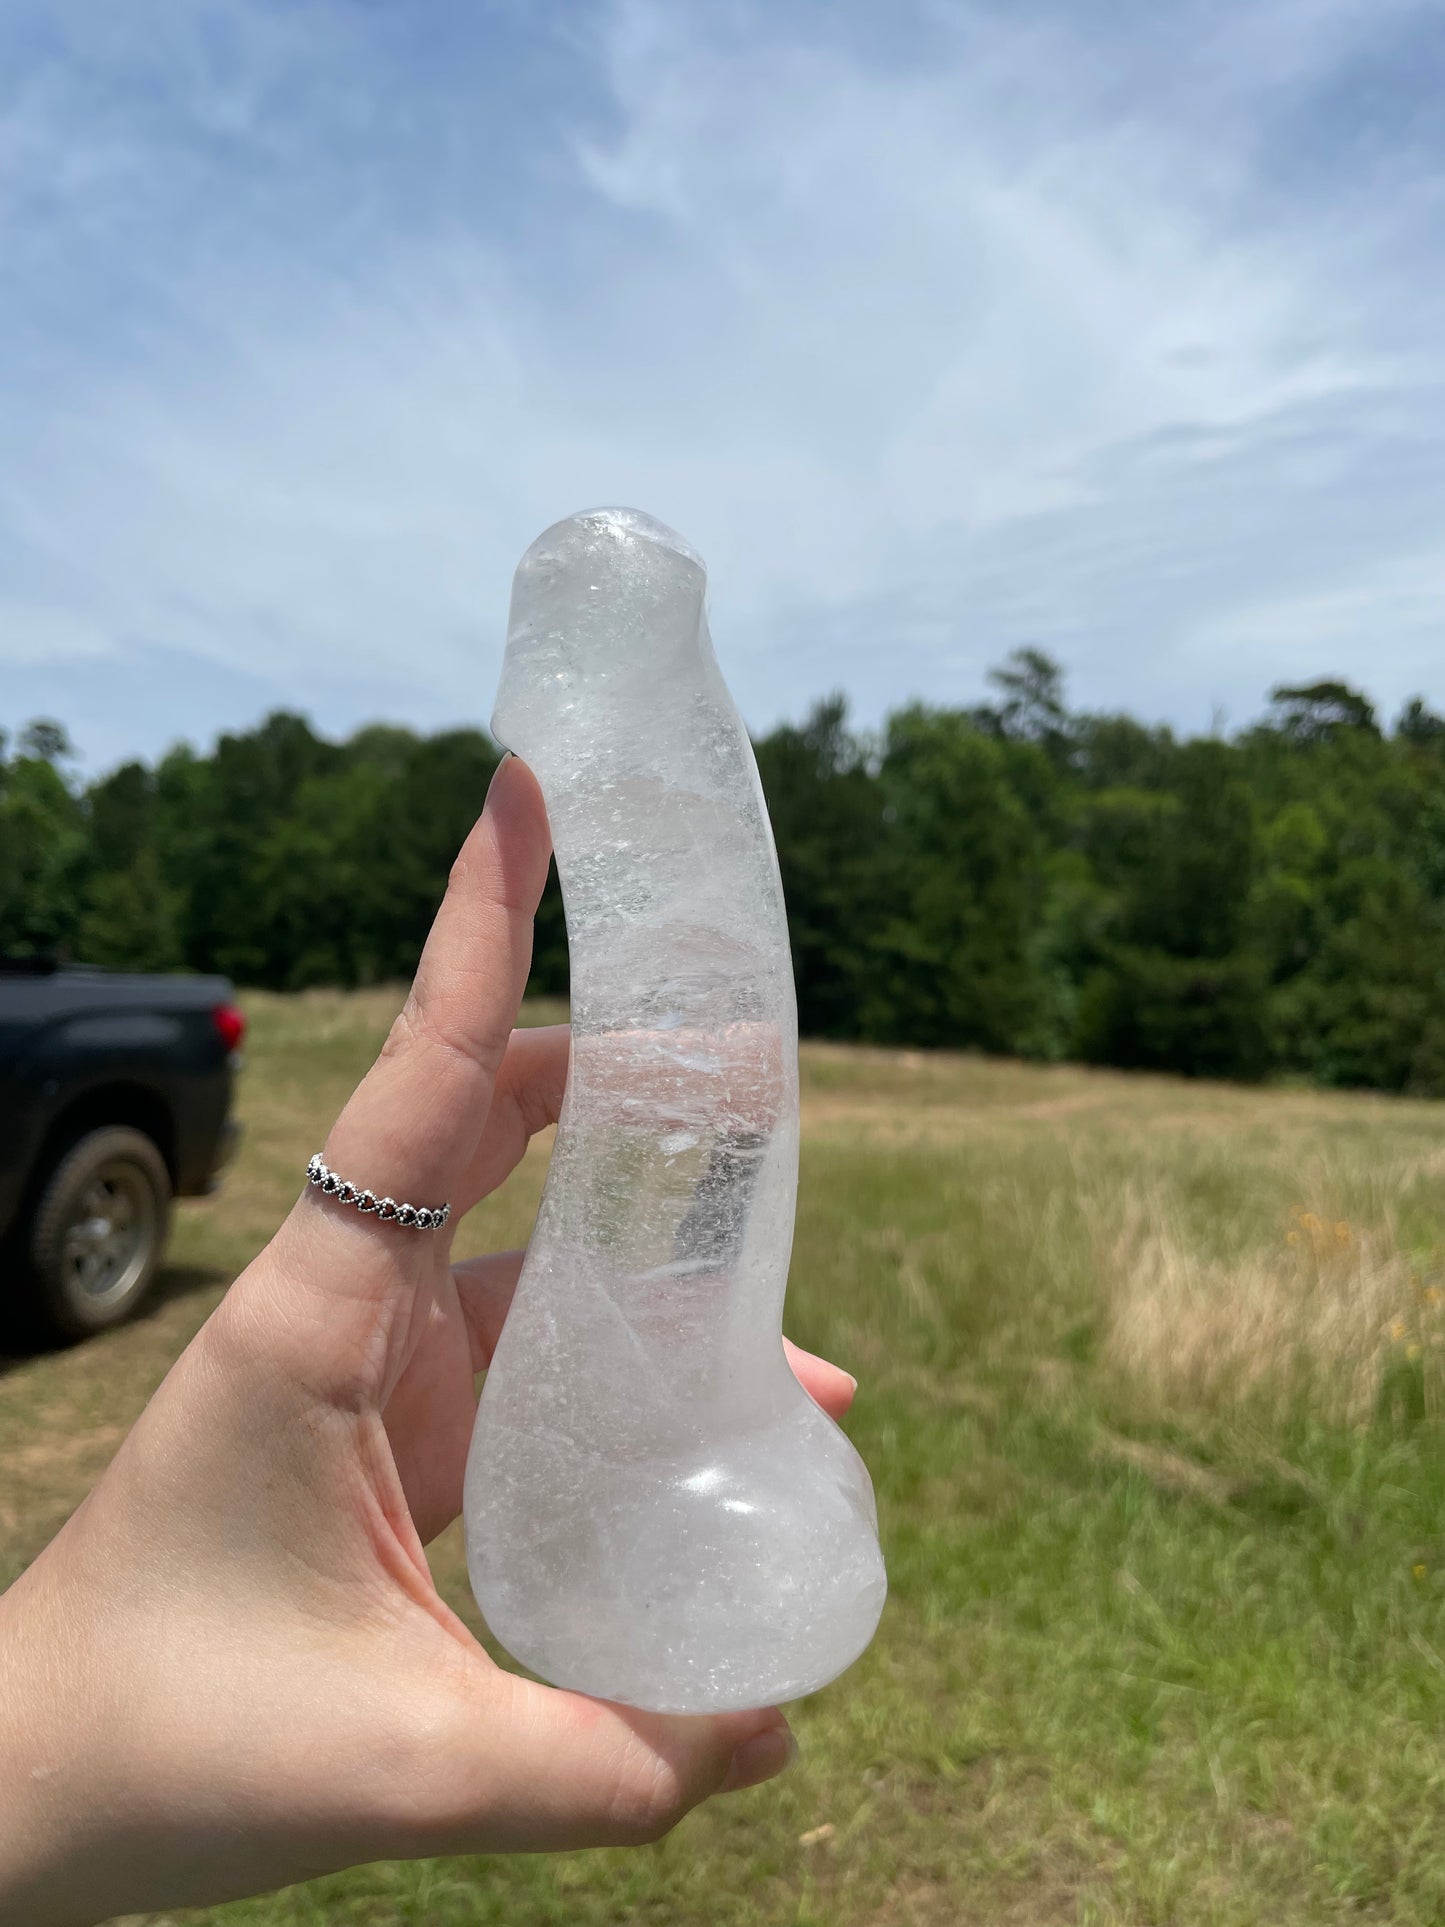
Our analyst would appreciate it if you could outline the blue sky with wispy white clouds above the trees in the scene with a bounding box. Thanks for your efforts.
[0,0,1445,767]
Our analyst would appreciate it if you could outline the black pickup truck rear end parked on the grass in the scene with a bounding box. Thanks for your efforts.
[0,960,245,1339]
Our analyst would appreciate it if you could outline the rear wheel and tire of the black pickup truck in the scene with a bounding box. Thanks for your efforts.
[29,1125,171,1339]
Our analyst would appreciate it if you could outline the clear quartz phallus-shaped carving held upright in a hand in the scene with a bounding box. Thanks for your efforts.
[464,509,886,1713]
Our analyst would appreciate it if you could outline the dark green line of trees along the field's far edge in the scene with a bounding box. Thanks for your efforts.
[0,649,1445,1095]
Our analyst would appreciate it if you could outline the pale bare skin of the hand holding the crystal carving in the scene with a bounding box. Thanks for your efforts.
[0,759,854,1927]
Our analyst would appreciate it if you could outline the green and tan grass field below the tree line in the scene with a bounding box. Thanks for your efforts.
[0,992,1445,1927]
